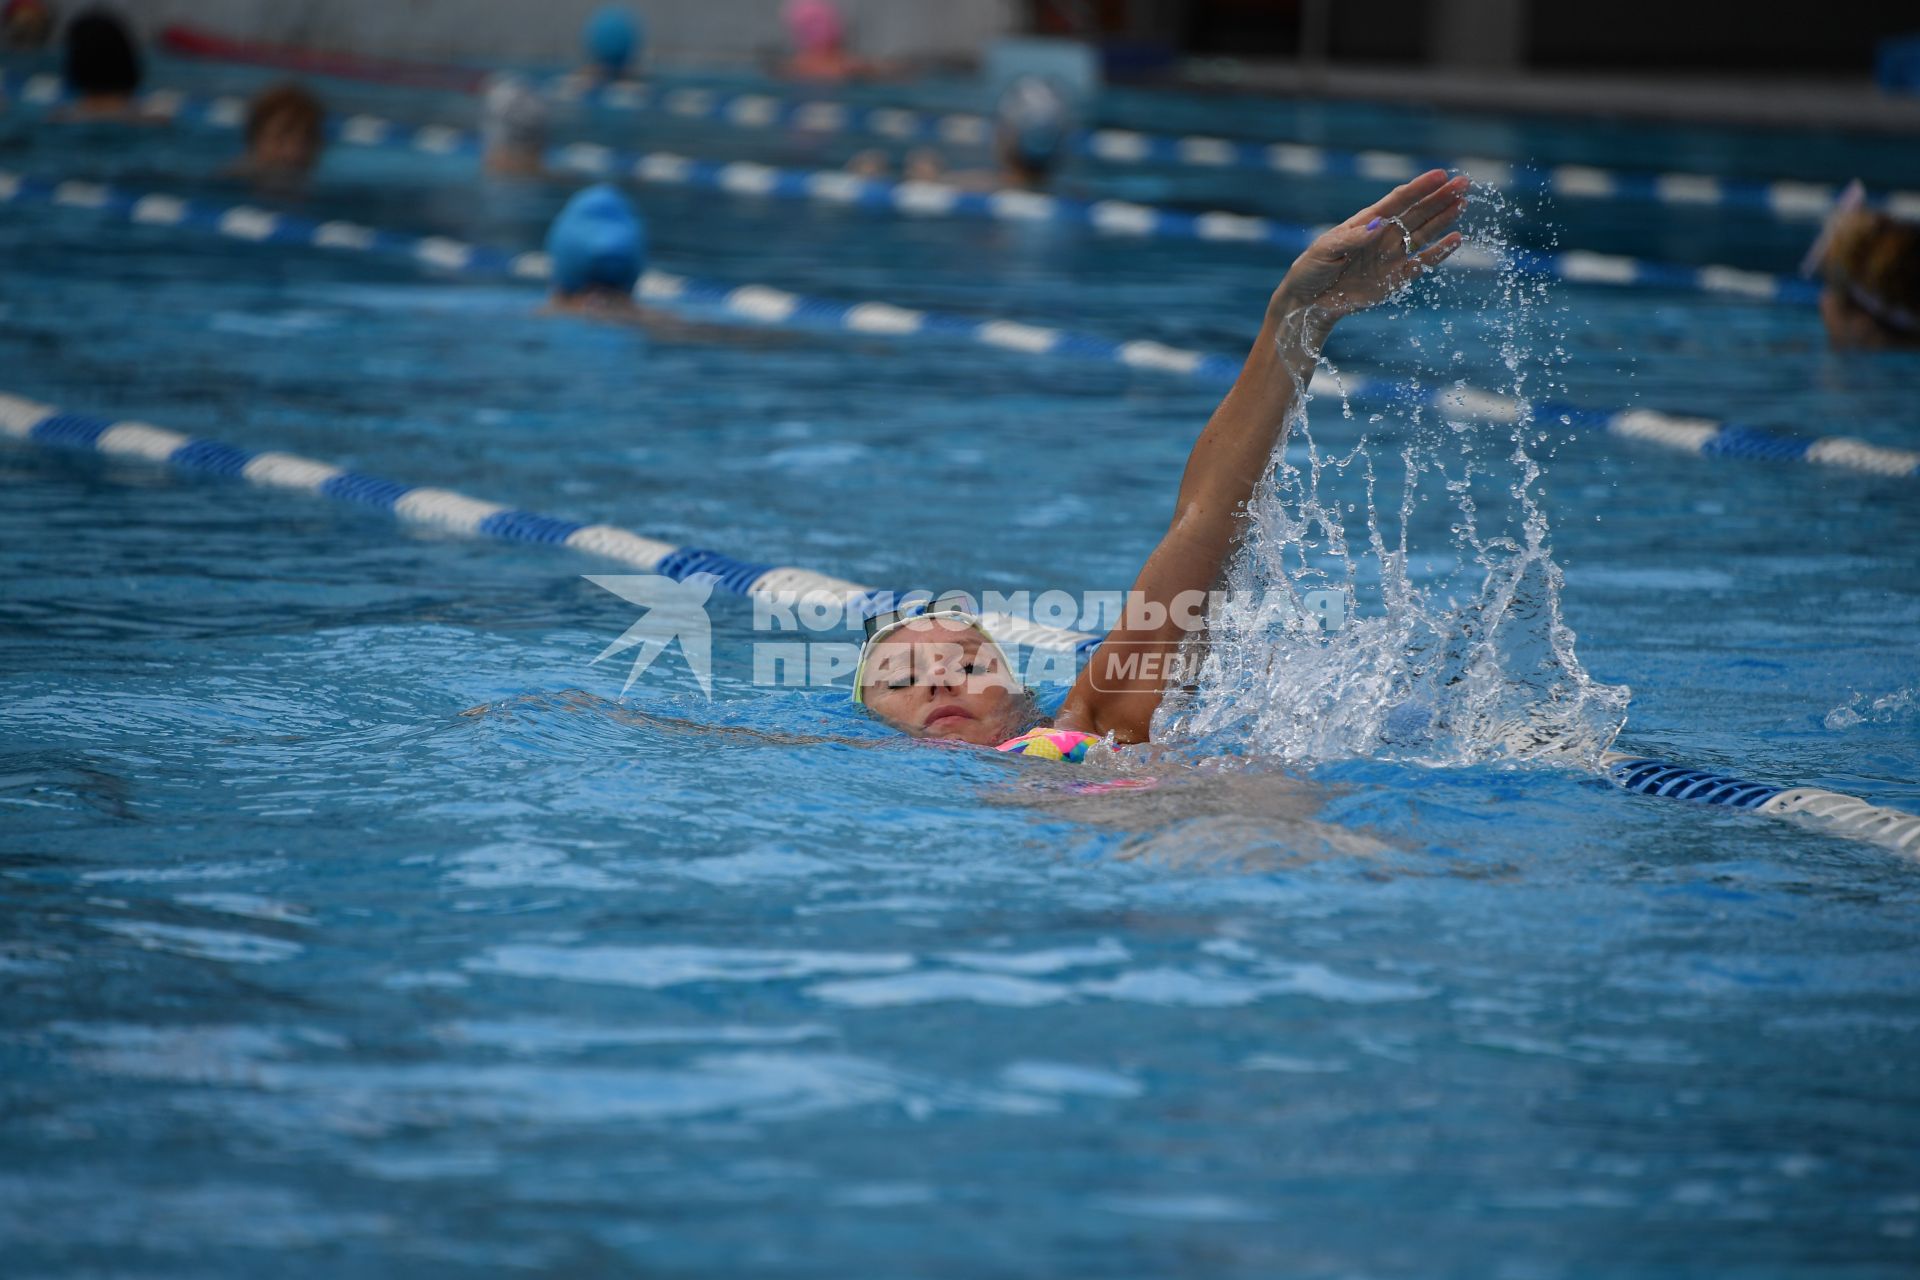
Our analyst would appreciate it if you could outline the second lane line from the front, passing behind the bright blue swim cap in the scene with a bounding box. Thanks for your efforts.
[0,169,1920,480]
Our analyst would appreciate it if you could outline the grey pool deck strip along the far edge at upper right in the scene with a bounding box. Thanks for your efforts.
[1179,58,1920,136]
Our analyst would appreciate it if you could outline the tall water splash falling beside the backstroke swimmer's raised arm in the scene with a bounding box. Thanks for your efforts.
[1154,188,1628,766]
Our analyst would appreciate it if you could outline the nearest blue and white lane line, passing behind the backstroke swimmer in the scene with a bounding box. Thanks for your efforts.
[0,393,1920,854]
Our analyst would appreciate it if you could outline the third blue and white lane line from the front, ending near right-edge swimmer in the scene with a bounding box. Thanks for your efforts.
[0,77,1820,307]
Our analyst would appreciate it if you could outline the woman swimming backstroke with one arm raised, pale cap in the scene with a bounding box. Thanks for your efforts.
[852,169,1467,760]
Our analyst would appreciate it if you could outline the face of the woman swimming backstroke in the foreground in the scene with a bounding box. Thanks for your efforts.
[860,618,1029,747]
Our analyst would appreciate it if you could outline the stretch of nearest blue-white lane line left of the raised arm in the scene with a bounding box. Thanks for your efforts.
[0,393,1100,656]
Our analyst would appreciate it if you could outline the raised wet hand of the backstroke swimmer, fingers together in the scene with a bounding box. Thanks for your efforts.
[1267,169,1469,345]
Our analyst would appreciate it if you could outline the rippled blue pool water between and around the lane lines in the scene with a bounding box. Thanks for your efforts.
[0,59,1920,1280]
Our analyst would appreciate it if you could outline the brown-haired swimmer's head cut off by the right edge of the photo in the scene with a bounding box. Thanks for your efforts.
[1801,182,1920,351]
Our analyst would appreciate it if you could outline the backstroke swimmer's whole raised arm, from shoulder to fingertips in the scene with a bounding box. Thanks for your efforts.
[1054,169,1467,743]
